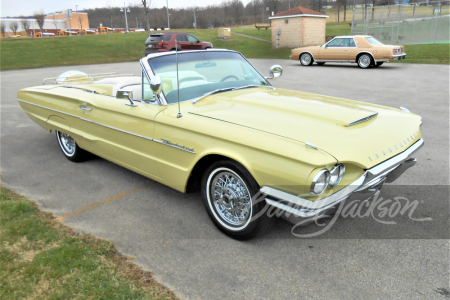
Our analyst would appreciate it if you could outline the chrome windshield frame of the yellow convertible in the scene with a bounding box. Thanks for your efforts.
[140,49,273,106]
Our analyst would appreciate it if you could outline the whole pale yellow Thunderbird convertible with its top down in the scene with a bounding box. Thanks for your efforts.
[18,49,423,239]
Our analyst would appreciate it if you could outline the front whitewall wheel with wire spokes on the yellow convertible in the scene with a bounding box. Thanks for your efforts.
[202,161,273,240]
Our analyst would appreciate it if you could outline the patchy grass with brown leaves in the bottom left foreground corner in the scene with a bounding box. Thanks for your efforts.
[0,187,176,300]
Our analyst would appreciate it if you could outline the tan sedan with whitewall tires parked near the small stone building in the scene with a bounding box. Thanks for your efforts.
[291,35,406,69]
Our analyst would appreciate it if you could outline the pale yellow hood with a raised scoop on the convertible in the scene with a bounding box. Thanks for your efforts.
[190,87,421,168]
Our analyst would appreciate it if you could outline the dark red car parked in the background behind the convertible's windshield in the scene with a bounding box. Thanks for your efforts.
[145,32,213,55]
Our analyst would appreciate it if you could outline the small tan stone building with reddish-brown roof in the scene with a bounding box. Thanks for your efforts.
[269,6,328,48]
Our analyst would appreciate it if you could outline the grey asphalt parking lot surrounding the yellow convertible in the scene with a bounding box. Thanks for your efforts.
[0,59,450,299]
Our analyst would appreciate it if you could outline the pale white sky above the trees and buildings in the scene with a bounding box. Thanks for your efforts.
[0,0,250,17]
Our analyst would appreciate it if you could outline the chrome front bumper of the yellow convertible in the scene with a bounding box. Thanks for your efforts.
[260,139,424,220]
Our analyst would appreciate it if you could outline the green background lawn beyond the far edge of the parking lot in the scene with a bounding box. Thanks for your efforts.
[0,23,449,70]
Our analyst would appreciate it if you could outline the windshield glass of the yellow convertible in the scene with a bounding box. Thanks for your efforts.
[148,51,270,104]
